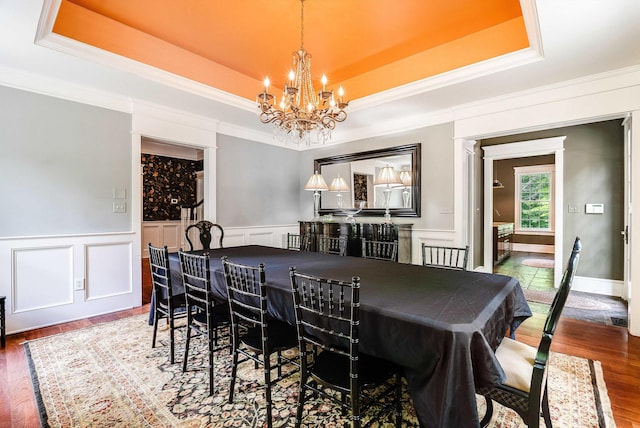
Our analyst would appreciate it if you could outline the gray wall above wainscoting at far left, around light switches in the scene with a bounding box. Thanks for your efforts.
[0,86,131,237]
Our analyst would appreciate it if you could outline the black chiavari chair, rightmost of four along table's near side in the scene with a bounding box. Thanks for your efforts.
[290,267,402,428]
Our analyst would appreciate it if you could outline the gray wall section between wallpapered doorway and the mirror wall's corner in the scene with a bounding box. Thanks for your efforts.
[216,135,301,227]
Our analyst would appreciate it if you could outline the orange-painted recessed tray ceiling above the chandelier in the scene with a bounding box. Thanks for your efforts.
[53,0,529,99]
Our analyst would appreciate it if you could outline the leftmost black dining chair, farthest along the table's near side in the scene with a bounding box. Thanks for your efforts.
[148,243,187,364]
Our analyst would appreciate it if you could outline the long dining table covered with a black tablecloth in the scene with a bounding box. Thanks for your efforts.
[154,245,531,427]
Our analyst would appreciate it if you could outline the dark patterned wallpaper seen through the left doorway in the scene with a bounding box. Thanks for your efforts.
[141,153,202,221]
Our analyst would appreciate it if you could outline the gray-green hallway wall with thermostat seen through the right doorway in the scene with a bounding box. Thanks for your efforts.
[483,120,624,280]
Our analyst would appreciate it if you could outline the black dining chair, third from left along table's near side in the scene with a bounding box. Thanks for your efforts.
[222,257,300,428]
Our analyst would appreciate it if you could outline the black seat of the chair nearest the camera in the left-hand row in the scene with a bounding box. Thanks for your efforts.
[310,351,398,389]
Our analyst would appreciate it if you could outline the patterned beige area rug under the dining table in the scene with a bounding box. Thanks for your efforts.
[24,315,615,428]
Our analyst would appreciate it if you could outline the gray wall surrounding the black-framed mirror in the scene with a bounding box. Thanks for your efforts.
[298,123,454,230]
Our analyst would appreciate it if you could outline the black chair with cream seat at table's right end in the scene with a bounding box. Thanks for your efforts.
[478,238,582,428]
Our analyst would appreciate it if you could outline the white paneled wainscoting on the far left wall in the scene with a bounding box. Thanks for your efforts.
[0,232,141,333]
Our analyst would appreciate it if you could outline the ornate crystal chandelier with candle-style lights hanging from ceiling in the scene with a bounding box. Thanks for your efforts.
[256,0,349,145]
